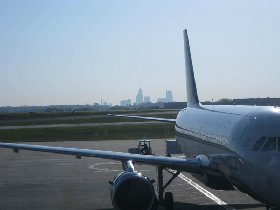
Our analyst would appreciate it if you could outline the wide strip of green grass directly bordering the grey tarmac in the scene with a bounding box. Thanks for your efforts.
[0,123,174,142]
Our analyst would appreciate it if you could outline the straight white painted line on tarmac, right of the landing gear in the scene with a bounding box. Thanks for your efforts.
[179,173,234,210]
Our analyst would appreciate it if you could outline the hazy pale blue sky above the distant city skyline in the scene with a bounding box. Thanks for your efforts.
[0,0,280,106]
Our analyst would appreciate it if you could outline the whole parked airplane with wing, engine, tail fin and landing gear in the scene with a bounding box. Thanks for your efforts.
[0,30,280,210]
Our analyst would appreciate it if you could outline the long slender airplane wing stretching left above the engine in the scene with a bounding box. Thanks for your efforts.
[0,142,202,173]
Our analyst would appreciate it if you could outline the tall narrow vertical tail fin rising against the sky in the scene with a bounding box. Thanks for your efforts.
[183,29,199,107]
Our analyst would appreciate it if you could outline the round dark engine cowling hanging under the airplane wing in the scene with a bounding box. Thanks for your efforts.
[111,171,157,210]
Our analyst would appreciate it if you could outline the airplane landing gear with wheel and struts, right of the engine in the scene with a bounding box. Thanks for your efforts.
[157,167,181,210]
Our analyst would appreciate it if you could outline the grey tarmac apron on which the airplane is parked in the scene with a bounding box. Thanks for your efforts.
[0,140,265,210]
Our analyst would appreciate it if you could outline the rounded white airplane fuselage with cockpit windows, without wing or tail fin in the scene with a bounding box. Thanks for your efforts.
[175,105,280,207]
